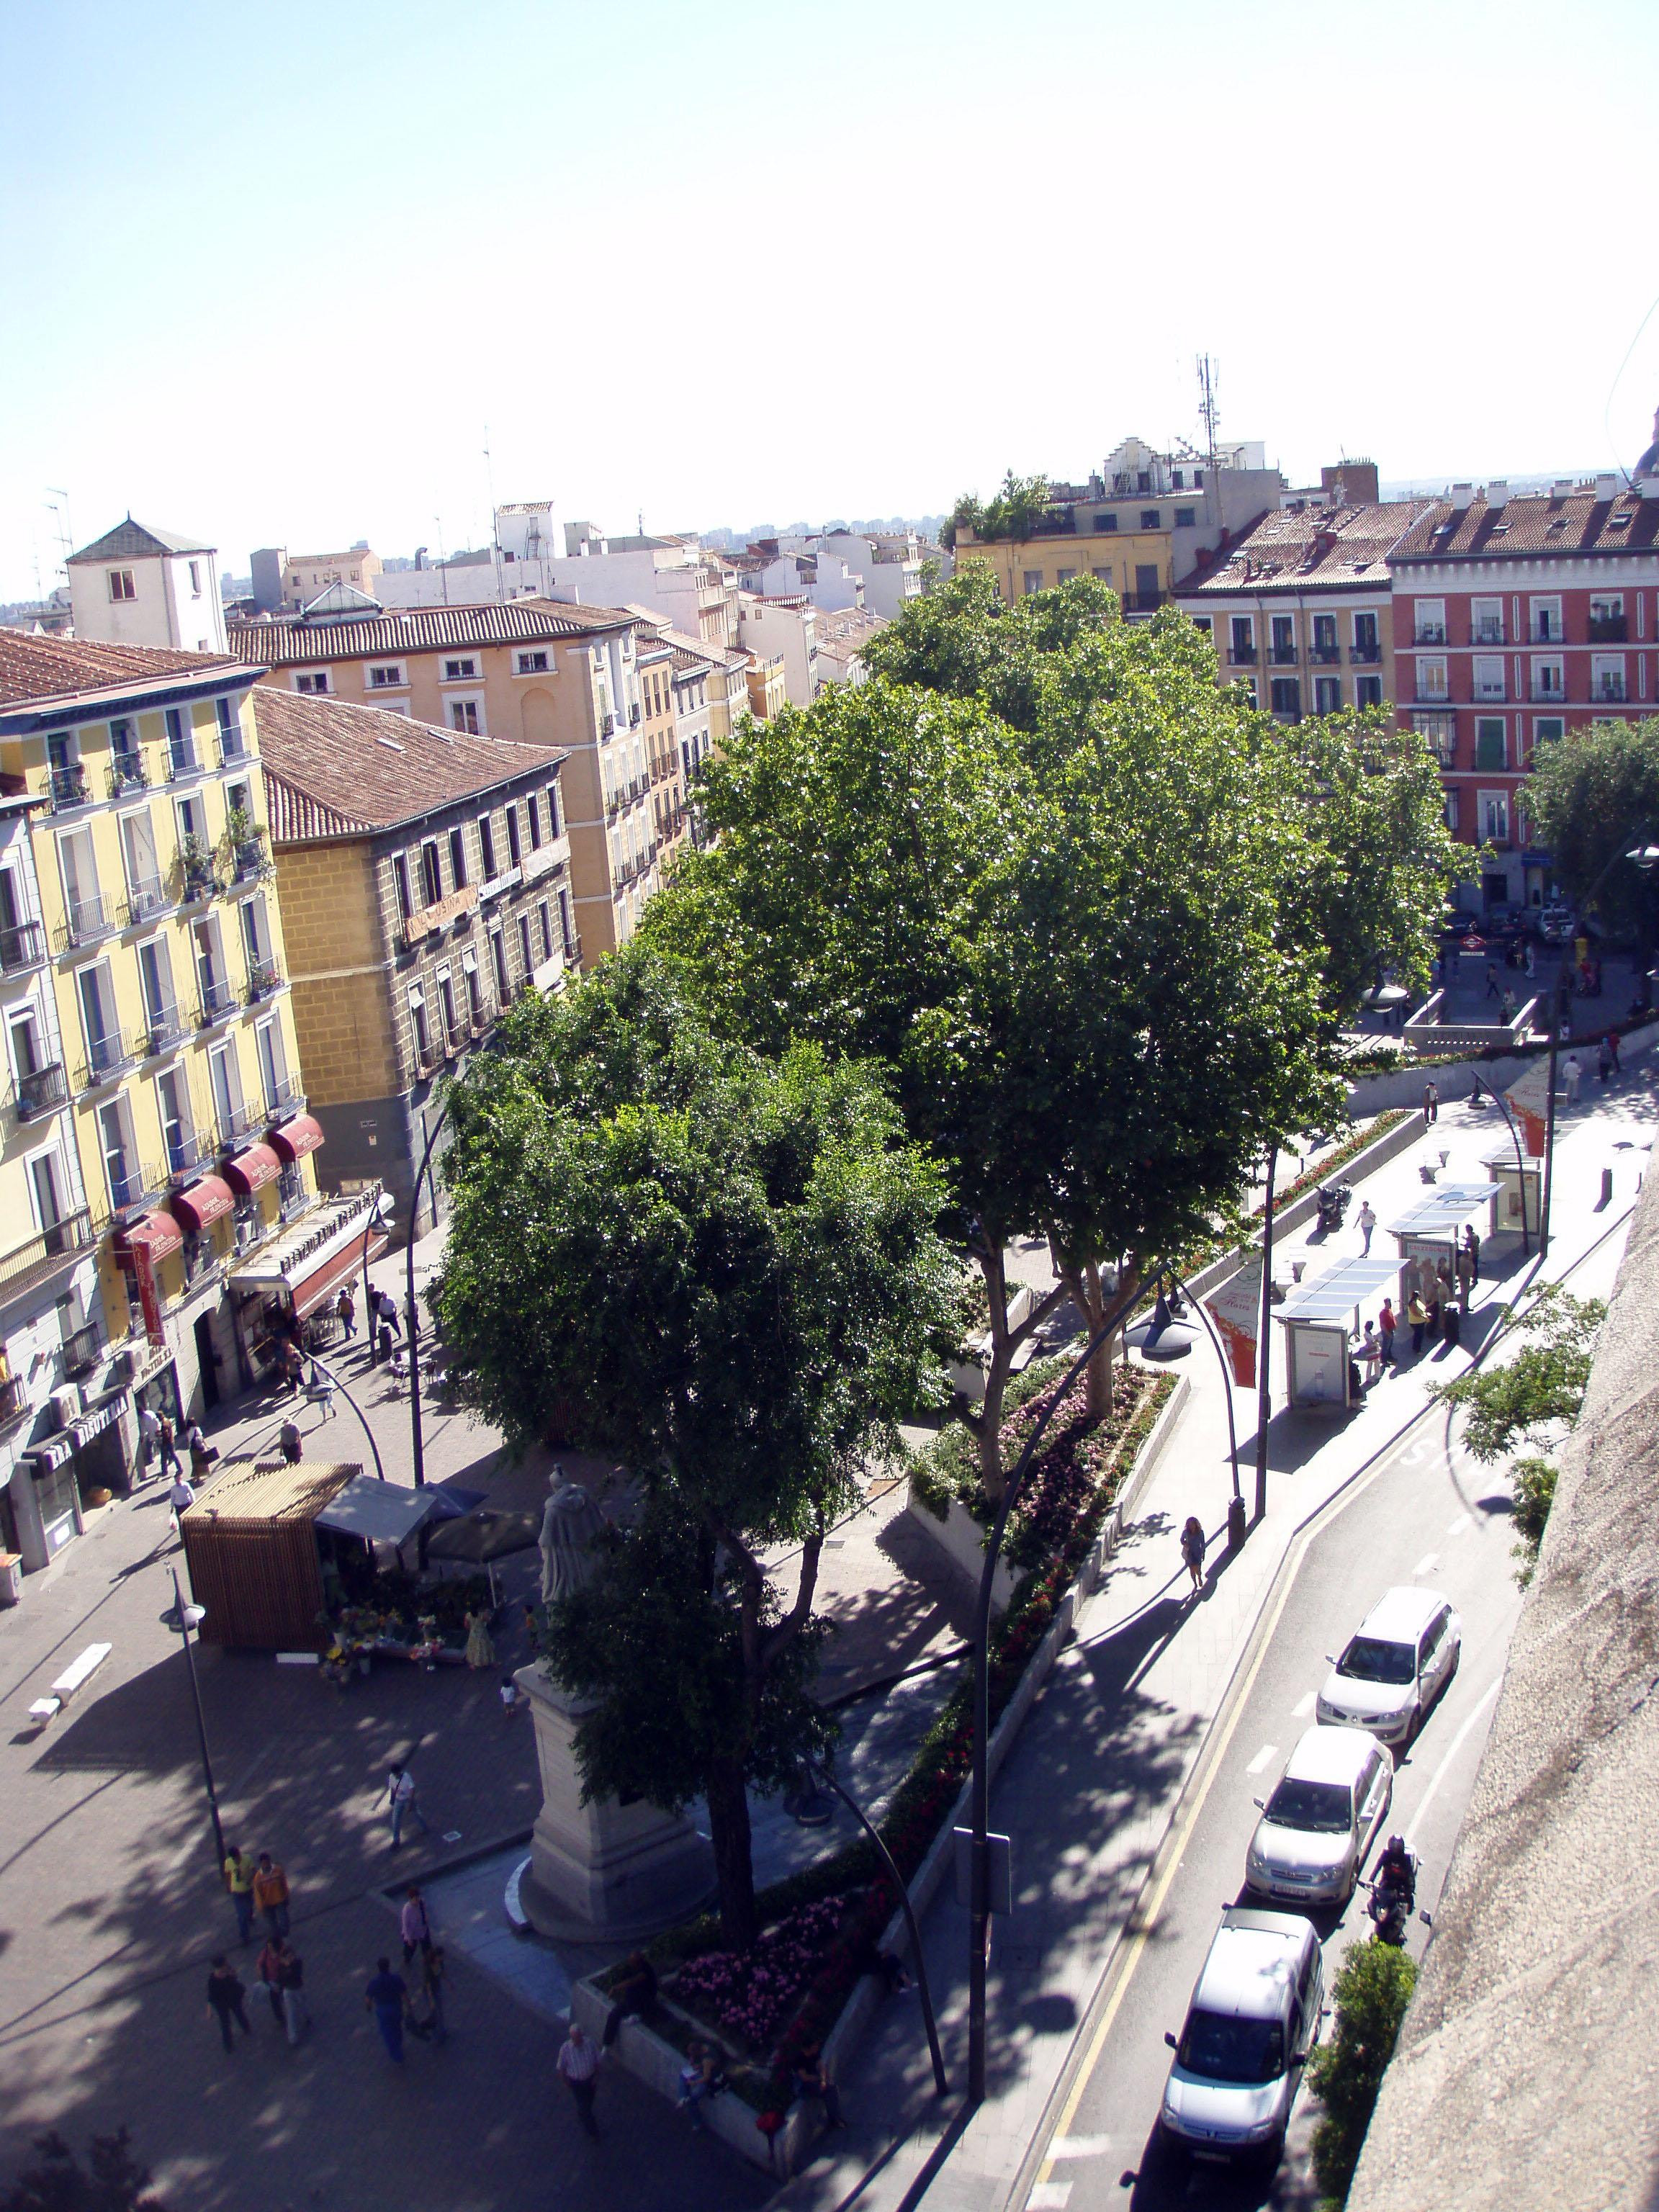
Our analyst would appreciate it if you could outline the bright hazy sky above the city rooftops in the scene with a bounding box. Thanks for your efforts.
[0,0,1659,600]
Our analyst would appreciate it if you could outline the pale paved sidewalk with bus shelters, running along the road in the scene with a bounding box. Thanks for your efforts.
[778,1064,1655,2212]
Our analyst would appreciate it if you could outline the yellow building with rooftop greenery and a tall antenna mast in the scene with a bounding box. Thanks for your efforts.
[946,438,1285,610]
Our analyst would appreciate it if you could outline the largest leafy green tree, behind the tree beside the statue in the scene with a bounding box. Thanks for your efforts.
[646,615,1336,1498]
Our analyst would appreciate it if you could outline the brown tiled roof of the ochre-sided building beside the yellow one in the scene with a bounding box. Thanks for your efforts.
[254,685,566,845]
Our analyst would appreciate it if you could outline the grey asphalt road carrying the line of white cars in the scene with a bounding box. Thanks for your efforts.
[1028,1382,1519,2212]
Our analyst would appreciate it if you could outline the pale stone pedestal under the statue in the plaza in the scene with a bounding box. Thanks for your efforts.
[516,1665,714,1942]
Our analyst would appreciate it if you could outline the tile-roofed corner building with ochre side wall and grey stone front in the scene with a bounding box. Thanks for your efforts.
[256,688,579,1236]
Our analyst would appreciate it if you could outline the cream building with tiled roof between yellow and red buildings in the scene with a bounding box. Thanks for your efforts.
[1177,500,1431,721]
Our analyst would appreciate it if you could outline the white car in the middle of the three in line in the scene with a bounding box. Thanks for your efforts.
[1246,1727,1393,1905]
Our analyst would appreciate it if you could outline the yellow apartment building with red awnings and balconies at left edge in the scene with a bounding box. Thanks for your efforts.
[0,633,330,1539]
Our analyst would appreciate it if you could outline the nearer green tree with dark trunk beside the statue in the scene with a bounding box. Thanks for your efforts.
[436,947,956,1944]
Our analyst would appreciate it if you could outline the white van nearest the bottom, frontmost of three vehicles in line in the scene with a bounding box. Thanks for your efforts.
[1159,1905,1325,2172]
